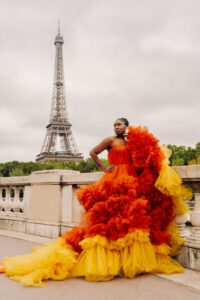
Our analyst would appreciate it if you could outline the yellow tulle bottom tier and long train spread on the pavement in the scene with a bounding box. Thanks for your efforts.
[3,230,184,286]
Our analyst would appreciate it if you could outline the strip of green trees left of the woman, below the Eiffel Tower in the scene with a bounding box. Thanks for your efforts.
[0,158,108,177]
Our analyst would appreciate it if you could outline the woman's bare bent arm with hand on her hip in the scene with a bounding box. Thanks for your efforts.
[89,137,115,172]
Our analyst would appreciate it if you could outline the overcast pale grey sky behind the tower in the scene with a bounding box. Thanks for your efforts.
[0,0,200,162]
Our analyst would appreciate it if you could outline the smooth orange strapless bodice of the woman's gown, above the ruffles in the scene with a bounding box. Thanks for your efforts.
[108,145,131,165]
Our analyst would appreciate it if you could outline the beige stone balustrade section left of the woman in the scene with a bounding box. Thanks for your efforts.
[0,170,102,238]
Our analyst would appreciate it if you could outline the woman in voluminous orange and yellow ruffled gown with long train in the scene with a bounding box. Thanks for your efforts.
[2,118,191,286]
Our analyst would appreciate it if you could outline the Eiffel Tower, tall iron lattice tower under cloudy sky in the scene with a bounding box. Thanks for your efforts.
[36,25,83,162]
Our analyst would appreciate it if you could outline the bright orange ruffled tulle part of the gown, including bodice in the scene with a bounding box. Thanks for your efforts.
[66,127,173,245]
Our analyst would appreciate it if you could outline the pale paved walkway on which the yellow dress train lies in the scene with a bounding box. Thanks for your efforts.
[0,230,200,300]
